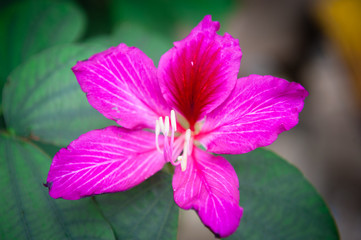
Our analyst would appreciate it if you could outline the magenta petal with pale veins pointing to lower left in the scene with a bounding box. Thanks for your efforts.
[47,126,165,200]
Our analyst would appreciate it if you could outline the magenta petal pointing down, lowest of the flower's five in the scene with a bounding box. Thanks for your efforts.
[173,148,243,237]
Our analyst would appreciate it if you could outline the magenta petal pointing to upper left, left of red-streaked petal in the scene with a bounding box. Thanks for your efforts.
[72,44,169,128]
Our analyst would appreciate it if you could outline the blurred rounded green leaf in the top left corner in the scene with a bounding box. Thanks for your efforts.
[0,0,85,105]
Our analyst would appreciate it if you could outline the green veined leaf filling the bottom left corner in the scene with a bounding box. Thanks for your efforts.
[0,134,114,240]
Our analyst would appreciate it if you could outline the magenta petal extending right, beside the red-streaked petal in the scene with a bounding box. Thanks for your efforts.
[198,75,308,154]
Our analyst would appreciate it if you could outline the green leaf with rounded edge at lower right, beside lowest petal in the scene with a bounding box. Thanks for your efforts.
[225,149,339,240]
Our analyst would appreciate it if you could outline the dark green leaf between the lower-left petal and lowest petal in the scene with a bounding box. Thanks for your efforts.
[96,172,178,240]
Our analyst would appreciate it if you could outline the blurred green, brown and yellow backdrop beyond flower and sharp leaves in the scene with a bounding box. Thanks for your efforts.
[0,0,361,240]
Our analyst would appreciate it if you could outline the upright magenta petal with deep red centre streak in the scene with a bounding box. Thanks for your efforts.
[158,16,242,126]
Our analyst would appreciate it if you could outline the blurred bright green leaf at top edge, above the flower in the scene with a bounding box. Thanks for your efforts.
[111,0,236,36]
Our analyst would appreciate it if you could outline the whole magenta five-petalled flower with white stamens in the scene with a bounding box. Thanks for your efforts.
[47,16,308,237]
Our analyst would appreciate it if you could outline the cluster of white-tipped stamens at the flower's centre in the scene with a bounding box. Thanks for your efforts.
[155,110,193,171]
